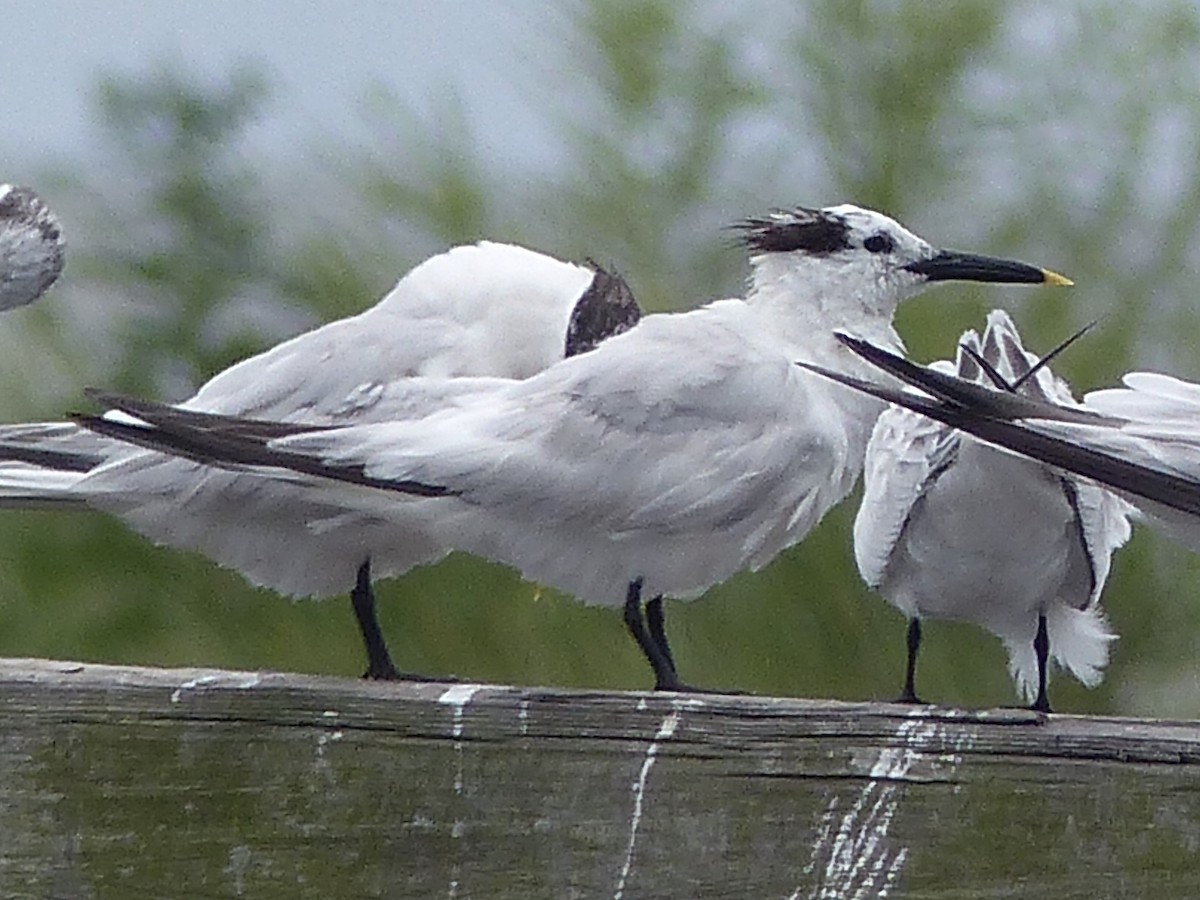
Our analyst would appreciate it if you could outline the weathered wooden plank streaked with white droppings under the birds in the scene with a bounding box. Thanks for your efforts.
[0,660,1200,900]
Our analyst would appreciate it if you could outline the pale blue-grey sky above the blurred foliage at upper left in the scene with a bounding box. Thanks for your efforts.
[0,0,566,181]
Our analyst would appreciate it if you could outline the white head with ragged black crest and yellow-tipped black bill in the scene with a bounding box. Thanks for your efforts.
[740,204,1070,320]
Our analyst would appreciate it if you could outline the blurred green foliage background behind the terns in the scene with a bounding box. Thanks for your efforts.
[0,0,1200,715]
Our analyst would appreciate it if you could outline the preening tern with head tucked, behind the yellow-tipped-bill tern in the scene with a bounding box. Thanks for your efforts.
[0,242,640,678]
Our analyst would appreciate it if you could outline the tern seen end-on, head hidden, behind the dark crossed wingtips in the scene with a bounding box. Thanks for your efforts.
[854,310,1130,712]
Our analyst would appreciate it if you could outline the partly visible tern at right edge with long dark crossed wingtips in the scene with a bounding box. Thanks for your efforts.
[806,337,1200,561]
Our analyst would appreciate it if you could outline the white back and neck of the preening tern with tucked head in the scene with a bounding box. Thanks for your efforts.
[186,242,594,424]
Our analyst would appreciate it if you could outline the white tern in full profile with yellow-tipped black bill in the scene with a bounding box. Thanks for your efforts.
[83,205,1066,690]
